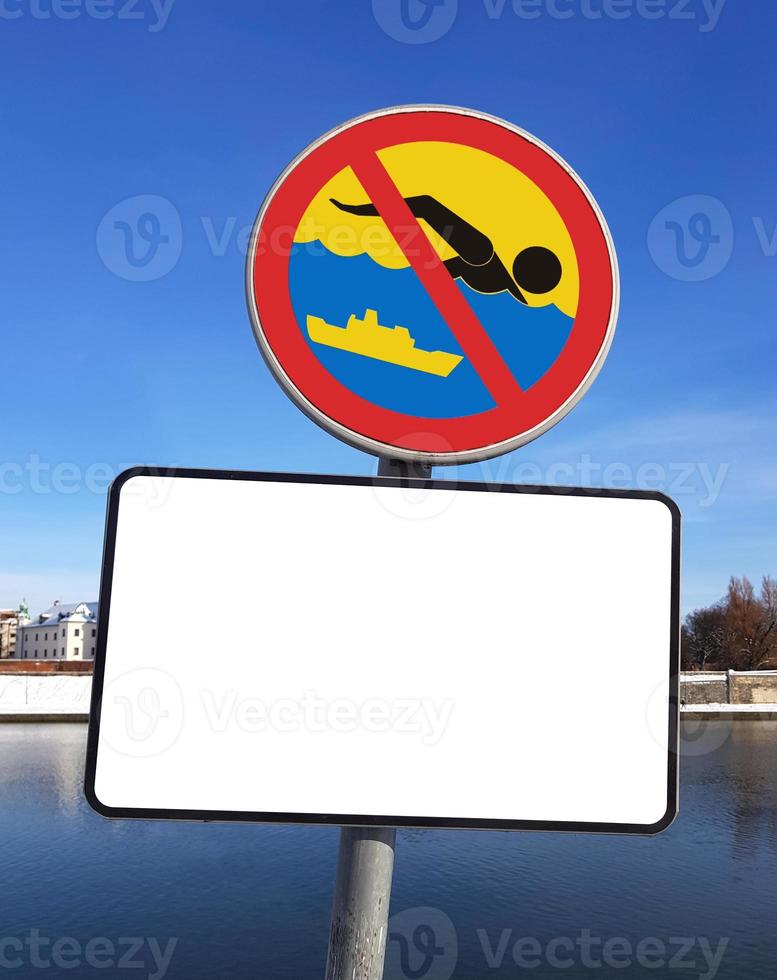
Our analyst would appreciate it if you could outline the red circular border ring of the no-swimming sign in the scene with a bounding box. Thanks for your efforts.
[249,109,615,458]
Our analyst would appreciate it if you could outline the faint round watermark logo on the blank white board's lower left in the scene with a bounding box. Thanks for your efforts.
[103,667,183,759]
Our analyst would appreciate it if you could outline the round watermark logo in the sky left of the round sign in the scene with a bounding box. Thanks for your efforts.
[97,194,183,282]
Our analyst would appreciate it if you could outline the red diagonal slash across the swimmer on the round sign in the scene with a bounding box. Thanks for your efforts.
[351,153,521,405]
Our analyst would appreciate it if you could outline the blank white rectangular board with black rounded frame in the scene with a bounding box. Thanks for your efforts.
[87,471,679,832]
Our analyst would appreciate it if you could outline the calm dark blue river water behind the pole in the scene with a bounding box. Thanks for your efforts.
[0,722,777,980]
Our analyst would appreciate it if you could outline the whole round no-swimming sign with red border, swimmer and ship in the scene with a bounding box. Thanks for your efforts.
[246,106,618,464]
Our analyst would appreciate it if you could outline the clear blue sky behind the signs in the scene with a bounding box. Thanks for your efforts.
[0,0,777,611]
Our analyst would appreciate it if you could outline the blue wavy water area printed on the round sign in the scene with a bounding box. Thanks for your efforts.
[289,242,573,418]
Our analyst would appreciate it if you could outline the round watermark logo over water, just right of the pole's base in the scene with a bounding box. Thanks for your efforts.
[385,908,459,980]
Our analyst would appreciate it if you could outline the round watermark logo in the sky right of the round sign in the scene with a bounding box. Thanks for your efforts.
[648,194,734,282]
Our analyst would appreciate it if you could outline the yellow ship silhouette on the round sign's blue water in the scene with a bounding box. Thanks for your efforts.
[307,310,464,378]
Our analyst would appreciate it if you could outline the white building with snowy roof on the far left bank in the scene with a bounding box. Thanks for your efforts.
[14,602,97,660]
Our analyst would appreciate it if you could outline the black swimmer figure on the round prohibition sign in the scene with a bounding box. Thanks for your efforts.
[329,194,561,304]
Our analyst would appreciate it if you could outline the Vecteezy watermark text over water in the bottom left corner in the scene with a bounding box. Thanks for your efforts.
[0,929,178,980]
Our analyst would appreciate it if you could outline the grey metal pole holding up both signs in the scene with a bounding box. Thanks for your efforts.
[326,459,432,980]
